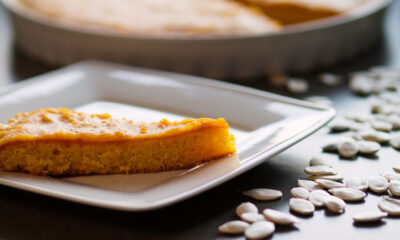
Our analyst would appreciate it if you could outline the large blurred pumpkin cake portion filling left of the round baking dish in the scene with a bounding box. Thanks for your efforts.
[19,0,280,37]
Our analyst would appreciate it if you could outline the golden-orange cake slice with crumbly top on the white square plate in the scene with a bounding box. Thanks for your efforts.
[0,109,235,175]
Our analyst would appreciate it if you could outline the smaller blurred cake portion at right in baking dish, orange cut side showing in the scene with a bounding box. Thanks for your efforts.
[237,0,371,25]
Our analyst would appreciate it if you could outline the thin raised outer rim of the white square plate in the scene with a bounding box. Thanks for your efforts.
[0,60,335,211]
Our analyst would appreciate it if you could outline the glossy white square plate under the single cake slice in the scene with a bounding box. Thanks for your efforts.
[0,62,335,211]
